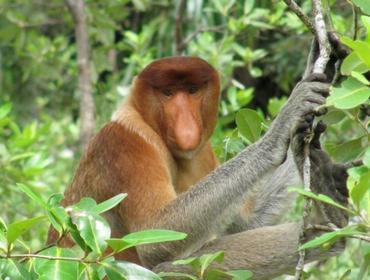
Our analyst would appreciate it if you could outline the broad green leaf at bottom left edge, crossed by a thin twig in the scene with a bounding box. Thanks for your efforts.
[34,247,82,280]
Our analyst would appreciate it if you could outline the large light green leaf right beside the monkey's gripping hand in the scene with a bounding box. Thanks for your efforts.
[327,77,370,109]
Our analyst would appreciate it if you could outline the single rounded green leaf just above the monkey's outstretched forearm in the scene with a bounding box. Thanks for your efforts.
[235,109,262,143]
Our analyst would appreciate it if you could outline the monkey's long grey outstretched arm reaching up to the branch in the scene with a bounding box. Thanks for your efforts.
[128,76,329,267]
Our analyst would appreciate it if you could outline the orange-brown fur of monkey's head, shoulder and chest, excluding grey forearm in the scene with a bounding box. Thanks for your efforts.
[48,57,220,263]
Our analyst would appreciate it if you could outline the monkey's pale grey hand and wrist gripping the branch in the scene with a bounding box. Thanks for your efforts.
[266,74,330,164]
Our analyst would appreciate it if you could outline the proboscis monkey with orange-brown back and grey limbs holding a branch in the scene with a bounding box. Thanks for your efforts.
[49,52,345,279]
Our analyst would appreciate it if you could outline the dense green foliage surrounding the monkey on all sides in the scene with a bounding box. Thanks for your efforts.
[0,0,370,279]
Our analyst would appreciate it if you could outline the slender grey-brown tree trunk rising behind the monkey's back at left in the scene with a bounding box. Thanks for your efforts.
[65,0,95,150]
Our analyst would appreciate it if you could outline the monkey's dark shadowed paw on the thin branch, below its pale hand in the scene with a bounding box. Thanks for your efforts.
[291,118,353,227]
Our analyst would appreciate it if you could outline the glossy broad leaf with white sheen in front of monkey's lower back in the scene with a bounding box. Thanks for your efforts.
[71,211,111,255]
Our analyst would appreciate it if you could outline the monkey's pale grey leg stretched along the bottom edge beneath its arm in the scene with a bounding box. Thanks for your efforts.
[154,223,343,279]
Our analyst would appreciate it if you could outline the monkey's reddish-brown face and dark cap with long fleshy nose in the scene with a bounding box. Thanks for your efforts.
[136,57,220,158]
